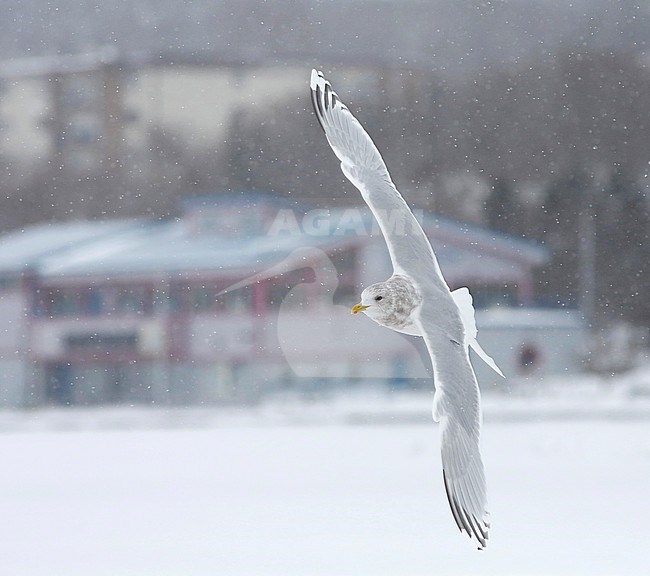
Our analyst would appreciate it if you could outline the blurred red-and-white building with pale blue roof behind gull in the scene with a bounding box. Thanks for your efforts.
[0,193,546,405]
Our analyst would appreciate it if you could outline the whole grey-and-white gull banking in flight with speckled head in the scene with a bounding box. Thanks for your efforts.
[310,70,503,549]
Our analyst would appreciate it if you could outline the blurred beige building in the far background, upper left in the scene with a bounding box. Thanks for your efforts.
[0,46,306,172]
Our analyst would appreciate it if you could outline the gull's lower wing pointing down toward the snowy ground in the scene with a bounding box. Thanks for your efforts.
[417,302,489,548]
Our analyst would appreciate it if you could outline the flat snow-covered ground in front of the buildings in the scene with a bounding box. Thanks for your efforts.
[0,368,650,576]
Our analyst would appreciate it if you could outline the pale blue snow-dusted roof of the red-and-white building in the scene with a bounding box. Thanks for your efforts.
[0,193,546,280]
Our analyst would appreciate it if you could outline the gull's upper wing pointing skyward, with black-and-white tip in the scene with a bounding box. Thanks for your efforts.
[311,70,449,293]
